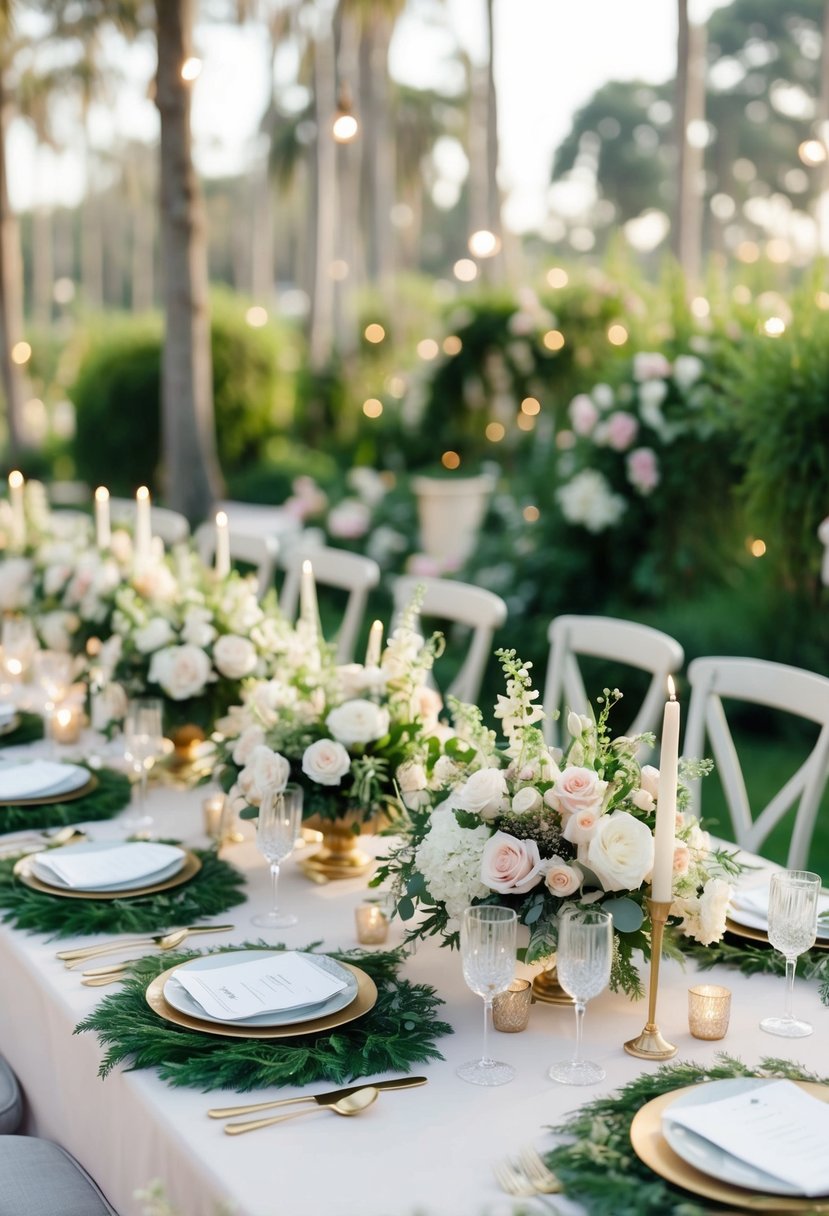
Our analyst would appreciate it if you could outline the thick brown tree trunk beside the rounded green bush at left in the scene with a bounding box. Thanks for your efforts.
[156,0,221,522]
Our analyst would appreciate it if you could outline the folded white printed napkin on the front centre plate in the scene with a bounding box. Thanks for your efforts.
[175,951,345,1021]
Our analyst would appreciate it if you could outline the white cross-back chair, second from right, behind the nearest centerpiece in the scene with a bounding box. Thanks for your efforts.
[543,615,684,759]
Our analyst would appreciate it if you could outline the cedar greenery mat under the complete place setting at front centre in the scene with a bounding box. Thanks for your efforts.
[75,941,452,1092]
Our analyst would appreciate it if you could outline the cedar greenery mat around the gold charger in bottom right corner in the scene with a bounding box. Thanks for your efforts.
[543,1054,827,1216]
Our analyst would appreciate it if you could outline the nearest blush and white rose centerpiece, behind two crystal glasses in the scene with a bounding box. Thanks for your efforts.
[374,651,738,996]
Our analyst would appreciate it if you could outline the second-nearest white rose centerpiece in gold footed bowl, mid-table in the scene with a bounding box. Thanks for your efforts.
[218,606,442,877]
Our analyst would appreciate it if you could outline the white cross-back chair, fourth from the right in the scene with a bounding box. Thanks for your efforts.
[280,545,380,663]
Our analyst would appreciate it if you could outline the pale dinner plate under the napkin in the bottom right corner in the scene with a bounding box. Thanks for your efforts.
[662,1076,803,1195]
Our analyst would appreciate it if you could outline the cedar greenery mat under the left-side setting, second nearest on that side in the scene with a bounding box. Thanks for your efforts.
[0,849,244,933]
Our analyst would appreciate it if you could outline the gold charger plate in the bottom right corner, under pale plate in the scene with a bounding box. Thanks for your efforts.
[631,1081,829,1212]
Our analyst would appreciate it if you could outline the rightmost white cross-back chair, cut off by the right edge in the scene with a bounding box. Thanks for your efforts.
[683,658,829,869]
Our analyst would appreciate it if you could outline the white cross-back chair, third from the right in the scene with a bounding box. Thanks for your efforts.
[393,575,507,704]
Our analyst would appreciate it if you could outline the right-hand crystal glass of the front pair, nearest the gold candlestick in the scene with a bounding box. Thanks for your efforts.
[549,907,613,1085]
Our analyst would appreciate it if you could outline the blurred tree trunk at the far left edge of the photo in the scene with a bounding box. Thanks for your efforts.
[0,74,23,463]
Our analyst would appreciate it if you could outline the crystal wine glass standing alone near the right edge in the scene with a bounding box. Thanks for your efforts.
[760,869,820,1038]
